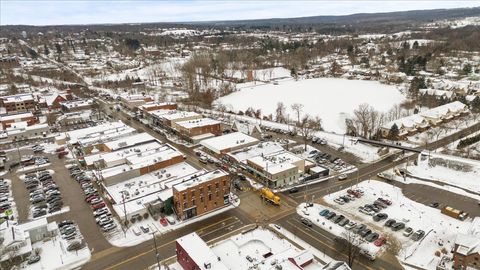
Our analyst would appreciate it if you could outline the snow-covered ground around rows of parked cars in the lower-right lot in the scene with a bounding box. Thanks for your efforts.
[316,180,480,269]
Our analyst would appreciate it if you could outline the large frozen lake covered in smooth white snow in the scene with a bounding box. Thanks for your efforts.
[217,78,404,133]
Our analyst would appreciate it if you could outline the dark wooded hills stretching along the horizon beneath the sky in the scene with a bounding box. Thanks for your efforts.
[0,7,480,34]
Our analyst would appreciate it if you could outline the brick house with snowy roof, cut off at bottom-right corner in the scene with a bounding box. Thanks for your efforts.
[453,234,480,269]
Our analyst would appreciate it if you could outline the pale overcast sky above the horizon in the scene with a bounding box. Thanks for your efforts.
[0,0,480,25]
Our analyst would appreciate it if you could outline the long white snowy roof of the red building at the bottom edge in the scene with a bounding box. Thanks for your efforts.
[177,232,228,270]
